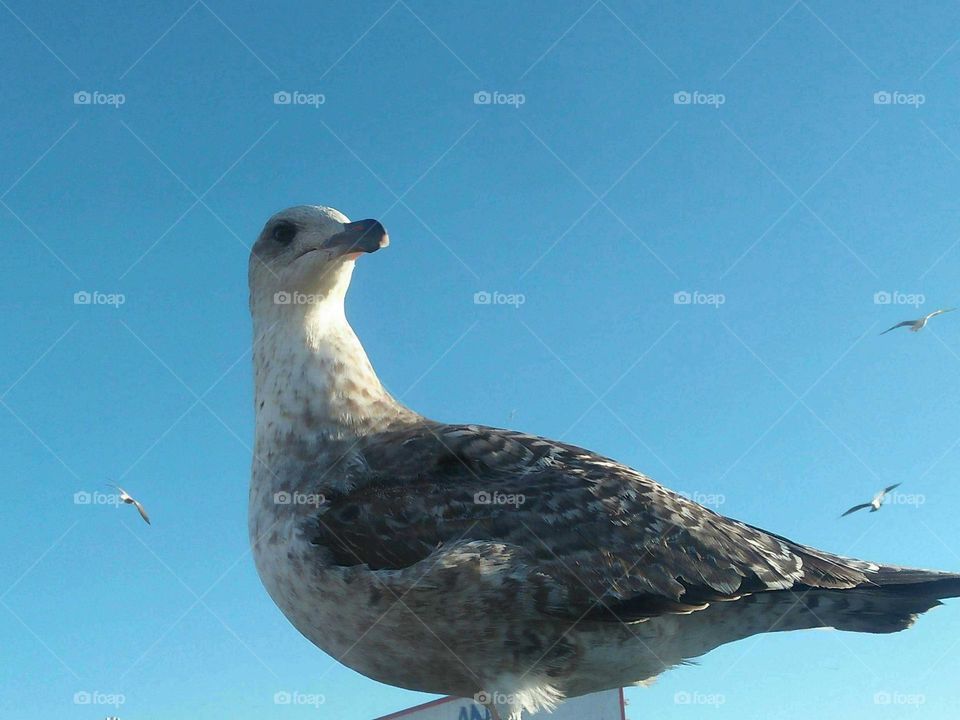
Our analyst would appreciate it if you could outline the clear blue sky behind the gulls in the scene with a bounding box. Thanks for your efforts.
[0,0,960,720]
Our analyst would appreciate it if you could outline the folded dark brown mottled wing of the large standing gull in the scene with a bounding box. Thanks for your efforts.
[306,424,874,620]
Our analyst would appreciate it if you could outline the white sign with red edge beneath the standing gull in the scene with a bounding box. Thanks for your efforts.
[376,689,626,720]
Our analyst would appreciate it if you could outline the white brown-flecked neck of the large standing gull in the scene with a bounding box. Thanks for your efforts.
[253,270,417,446]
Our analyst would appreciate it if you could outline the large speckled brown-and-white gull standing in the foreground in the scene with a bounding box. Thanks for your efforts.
[248,206,960,720]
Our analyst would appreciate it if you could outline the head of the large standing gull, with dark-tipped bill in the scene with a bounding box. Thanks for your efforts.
[249,205,389,314]
